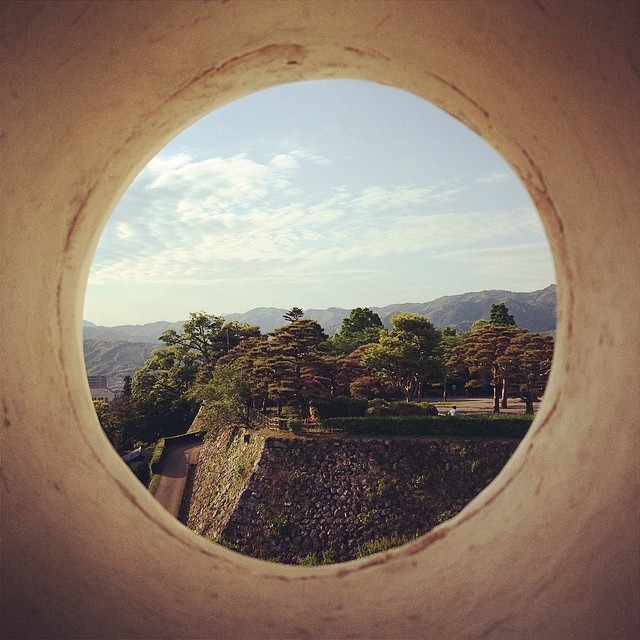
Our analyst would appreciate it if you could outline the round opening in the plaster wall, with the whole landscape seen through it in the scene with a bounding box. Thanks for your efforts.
[84,81,555,564]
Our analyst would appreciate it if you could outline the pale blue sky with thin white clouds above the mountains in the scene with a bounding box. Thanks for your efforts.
[84,80,555,326]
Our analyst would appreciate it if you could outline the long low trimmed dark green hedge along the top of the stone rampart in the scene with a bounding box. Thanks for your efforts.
[320,414,533,439]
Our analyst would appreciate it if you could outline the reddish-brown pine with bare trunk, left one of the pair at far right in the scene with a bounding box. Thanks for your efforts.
[446,324,521,413]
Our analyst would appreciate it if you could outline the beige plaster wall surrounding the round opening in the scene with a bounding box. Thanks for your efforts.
[0,0,640,639]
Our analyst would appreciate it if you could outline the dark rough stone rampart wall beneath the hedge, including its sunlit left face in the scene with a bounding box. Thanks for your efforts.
[189,434,518,564]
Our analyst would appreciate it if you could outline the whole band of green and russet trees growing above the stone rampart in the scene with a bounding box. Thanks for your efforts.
[96,303,553,448]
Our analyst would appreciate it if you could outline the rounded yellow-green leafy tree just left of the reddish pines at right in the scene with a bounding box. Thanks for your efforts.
[362,313,443,402]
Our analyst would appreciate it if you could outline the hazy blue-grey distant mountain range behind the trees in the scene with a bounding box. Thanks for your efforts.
[83,285,556,378]
